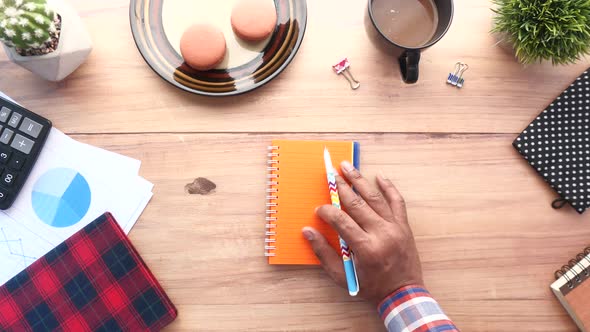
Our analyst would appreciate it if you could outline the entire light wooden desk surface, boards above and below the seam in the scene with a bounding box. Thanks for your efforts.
[0,0,590,331]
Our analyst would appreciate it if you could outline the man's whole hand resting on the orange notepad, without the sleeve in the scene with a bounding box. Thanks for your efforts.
[303,162,424,304]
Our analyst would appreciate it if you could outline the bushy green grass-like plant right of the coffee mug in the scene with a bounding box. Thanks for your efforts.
[492,0,590,65]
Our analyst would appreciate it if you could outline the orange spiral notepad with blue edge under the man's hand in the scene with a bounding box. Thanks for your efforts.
[265,140,359,265]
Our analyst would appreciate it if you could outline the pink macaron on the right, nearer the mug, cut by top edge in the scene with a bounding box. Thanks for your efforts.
[231,0,277,41]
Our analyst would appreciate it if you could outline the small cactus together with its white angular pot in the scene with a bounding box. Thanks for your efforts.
[0,0,92,81]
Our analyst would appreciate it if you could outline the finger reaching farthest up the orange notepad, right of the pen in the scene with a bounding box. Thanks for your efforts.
[341,161,392,220]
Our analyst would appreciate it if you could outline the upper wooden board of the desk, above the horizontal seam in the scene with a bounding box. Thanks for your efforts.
[0,0,589,133]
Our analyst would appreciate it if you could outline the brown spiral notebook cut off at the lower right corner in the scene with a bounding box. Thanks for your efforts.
[551,247,590,331]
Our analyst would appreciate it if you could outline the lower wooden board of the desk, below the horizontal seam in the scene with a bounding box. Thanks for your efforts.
[74,134,590,331]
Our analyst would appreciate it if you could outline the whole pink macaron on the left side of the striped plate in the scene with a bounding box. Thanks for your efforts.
[180,24,227,71]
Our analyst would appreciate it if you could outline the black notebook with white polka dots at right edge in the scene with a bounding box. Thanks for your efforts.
[513,71,590,213]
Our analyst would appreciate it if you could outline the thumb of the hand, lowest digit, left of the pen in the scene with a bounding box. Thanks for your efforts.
[302,227,346,288]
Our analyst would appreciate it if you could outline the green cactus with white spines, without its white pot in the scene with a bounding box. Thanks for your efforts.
[0,0,56,49]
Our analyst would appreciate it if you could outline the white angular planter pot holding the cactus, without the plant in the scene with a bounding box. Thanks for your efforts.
[4,0,92,81]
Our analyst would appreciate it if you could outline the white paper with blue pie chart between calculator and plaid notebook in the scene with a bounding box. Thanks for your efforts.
[6,129,152,244]
